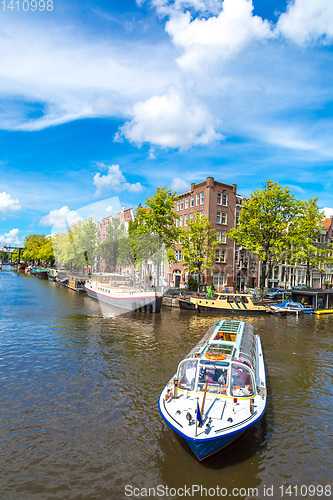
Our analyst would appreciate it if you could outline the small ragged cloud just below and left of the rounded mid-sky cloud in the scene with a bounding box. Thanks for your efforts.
[94,163,143,196]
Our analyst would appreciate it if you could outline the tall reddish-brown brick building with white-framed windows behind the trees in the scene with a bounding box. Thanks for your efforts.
[167,177,258,291]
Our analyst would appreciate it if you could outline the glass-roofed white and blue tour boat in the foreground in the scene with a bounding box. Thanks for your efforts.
[159,320,267,460]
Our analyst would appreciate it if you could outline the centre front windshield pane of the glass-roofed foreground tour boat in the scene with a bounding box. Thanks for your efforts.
[198,361,229,395]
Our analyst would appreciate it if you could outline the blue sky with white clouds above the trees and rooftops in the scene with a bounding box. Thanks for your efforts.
[0,0,333,245]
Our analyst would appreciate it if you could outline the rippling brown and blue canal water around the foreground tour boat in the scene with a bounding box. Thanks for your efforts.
[0,271,333,500]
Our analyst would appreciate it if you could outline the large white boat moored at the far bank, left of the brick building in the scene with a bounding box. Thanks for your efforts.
[85,273,162,312]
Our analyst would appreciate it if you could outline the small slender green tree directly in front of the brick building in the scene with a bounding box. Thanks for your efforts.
[179,215,217,291]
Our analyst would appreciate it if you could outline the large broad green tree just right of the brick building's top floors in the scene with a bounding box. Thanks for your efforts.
[228,180,298,291]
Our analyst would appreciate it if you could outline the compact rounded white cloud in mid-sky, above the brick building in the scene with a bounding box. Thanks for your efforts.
[121,89,223,149]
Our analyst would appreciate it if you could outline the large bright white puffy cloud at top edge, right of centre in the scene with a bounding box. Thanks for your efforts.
[166,0,273,71]
